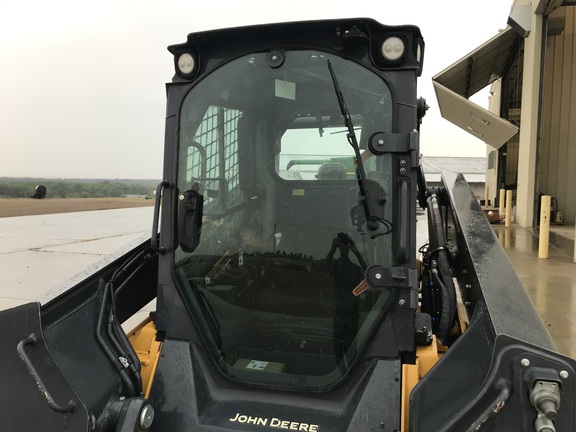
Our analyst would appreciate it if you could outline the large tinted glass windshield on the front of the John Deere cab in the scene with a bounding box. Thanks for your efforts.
[174,50,393,390]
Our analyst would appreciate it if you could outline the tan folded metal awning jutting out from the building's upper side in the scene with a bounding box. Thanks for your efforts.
[432,27,521,148]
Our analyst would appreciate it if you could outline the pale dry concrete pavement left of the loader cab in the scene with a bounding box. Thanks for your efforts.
[0,207,153,326]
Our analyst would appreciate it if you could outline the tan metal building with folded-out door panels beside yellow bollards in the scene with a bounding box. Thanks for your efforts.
[433,0,576,260]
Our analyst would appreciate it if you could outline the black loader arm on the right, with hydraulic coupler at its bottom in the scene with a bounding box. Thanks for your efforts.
[410,172,576,432]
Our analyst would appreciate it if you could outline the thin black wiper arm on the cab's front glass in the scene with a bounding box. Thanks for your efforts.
[326,60,382,234]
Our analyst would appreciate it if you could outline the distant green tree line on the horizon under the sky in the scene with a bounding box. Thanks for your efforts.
[0,180,153,198]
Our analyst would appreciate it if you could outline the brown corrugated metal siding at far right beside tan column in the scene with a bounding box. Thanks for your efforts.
[538,6,576,223]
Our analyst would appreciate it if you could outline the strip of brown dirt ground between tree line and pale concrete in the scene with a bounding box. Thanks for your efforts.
[0,198,154,217]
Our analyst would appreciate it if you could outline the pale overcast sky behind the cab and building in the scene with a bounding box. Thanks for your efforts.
[0,0,512,179]
